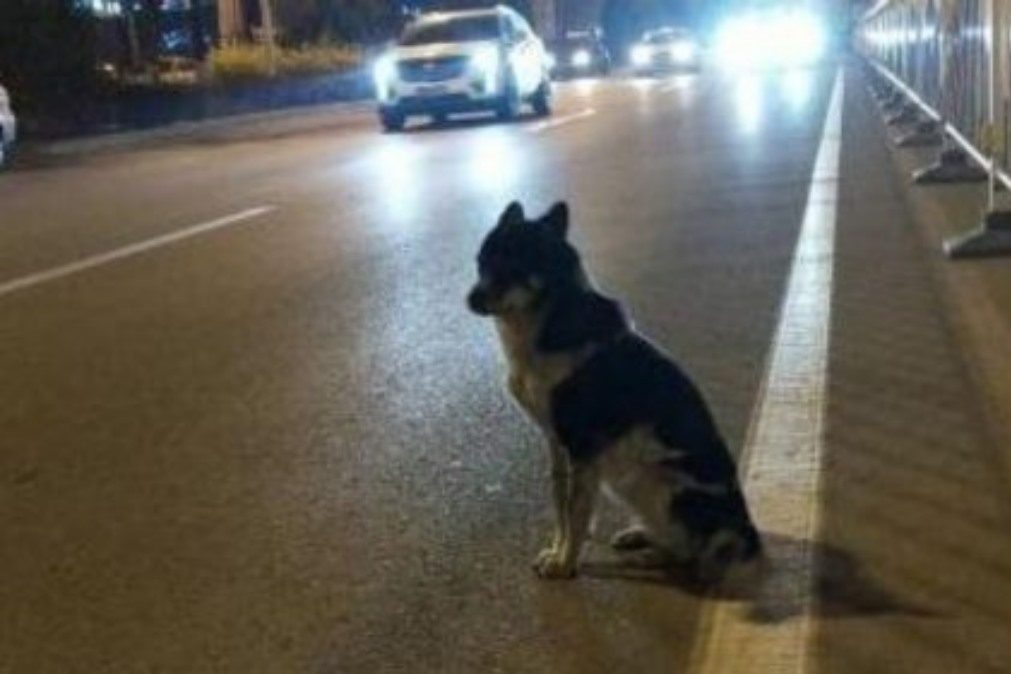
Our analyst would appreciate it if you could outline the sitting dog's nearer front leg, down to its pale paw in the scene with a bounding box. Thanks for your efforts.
[535,464,600,578]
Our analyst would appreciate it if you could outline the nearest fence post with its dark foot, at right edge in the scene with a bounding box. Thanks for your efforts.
[944,0,1011,259]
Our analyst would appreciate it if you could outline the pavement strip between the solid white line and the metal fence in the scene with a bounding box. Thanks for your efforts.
[812,69,1011,674]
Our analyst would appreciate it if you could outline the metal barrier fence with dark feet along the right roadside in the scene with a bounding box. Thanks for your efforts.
[857,0,1011,255]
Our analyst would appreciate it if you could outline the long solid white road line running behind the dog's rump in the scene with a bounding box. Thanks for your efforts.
[690,71,844,674]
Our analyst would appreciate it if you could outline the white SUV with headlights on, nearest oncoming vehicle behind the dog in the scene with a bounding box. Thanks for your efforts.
[375,6,551,130]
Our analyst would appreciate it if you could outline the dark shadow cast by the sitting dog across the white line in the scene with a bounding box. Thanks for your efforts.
[581,535,940,623]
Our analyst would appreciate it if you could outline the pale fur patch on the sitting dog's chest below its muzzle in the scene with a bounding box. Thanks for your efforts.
[495,319,580,430]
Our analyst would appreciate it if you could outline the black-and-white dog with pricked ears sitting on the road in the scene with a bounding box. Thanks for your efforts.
[467,202,762,583]
